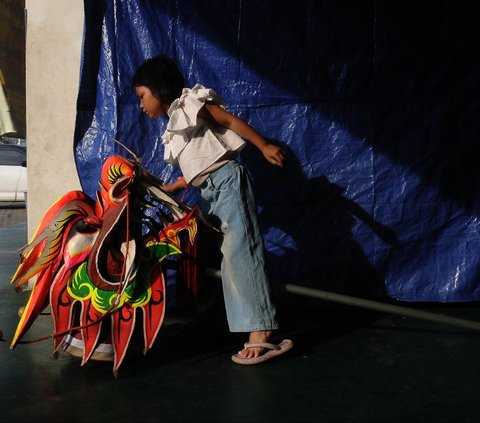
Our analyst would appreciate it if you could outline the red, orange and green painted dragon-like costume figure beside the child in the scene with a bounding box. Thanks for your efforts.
[10,147,199,375]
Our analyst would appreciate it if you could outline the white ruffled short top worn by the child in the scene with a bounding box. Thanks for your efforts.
[162,84,245,185]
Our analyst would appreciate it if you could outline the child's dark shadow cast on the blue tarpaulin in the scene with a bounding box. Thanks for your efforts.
[242,141,399,304]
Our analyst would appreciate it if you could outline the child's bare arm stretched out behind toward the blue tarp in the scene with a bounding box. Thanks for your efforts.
[198,103,285,166]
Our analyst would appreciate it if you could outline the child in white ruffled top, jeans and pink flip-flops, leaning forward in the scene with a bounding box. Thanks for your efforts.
[133,55,293,364]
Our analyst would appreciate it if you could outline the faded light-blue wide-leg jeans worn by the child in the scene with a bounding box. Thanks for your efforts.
[200,161,278,332]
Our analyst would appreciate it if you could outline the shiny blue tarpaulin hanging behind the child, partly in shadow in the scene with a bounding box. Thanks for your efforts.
[75,0,480,302]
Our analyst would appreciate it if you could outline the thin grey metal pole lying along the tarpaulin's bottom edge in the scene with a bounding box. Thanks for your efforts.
[285,284,480,331]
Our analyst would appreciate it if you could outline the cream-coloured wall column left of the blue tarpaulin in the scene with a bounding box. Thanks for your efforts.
[25,0,83,236]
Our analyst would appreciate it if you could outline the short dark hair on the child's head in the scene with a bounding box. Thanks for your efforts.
[132,54,185,104]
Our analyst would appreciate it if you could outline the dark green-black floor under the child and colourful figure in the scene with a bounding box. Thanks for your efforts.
[0,214,480,423]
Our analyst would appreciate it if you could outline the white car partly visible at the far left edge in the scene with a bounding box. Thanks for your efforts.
[0,144,27,202]
